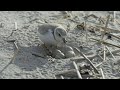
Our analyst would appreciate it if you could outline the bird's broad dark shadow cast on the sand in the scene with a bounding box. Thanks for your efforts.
[13,46,48,71]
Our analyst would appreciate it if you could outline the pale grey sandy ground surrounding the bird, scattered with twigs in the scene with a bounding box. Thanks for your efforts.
[0,11,120,79]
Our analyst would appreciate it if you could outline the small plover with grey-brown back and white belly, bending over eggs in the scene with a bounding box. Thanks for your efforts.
[38,23,67,47]
